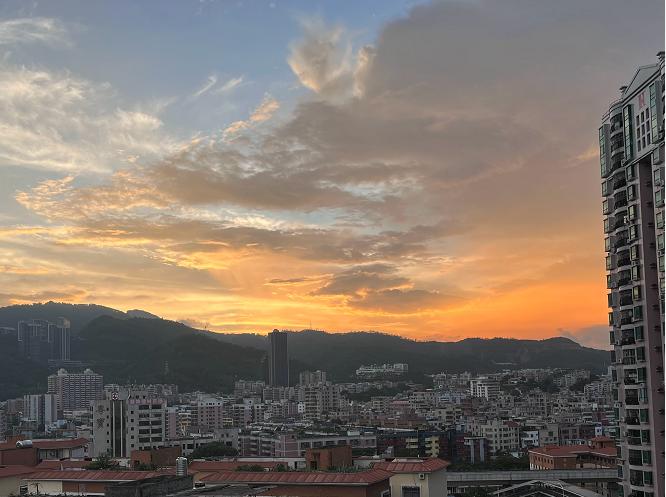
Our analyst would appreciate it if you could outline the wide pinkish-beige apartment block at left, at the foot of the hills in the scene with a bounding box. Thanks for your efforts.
[48,369,104,411]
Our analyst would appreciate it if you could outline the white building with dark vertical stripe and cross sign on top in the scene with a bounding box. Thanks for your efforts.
[93,389,167,457]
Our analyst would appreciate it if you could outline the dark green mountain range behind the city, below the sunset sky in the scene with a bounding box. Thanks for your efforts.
[0,302,610,400]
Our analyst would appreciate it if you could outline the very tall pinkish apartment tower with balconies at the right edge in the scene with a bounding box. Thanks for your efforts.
[599,52,665,497]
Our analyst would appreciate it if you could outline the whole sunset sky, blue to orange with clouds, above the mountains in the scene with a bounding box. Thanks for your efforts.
[0,0,664,348]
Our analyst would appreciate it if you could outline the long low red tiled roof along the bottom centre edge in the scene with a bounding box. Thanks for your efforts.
[201,469,392,486]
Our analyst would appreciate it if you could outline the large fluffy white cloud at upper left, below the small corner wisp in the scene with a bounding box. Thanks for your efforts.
[0,65,179,172]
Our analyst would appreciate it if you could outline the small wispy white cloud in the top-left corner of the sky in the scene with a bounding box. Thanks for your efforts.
[0,17,70,45]
